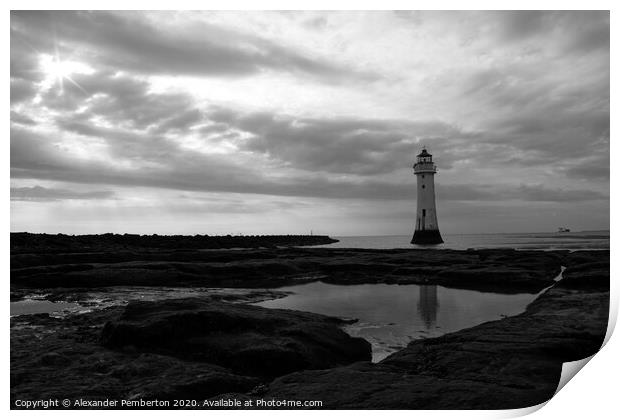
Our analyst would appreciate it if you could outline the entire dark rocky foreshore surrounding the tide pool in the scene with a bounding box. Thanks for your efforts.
[11,248,609,409]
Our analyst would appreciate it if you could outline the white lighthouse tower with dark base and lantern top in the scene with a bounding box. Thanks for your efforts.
[411,147,443,245]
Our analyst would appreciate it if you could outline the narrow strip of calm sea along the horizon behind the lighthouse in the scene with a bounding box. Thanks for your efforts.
[319,231,609,250]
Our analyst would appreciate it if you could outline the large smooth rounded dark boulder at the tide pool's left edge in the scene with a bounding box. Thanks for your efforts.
[101,298,371,377]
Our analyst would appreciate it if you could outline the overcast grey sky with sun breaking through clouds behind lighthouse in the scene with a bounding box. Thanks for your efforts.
[10,12,609,235]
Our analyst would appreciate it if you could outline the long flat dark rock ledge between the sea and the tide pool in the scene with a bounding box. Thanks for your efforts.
[11,247,568,298]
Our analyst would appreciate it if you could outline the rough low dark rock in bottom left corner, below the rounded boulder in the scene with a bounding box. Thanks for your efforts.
[11,308,260,408]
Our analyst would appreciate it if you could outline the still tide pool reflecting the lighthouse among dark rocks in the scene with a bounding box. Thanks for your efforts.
[257,282,536,362]
